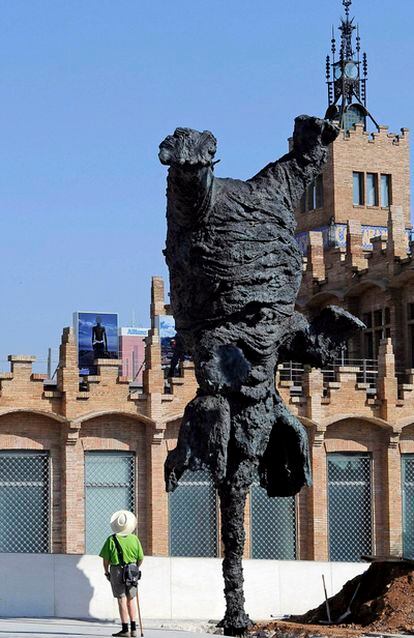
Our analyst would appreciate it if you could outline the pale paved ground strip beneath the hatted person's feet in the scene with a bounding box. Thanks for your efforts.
[0,618,220,638]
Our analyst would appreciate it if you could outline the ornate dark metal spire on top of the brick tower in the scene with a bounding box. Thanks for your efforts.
[326,0,378,131]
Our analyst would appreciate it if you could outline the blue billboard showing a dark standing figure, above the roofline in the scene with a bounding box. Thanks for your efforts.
[74,312,118,375]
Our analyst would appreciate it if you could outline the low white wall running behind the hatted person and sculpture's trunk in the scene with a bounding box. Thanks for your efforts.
[0,554,368,620]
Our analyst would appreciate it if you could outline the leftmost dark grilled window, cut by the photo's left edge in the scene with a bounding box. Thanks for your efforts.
[0,451,50,553]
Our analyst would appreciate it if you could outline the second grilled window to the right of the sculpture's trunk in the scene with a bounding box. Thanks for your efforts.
[328,453,373,561]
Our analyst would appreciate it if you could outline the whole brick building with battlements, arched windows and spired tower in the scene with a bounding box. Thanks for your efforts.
[0,2,414,560]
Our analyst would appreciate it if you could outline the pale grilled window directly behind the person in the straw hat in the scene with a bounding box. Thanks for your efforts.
[85,452,135,554]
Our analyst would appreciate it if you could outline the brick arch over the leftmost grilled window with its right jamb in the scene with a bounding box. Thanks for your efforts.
[0,409,65,553]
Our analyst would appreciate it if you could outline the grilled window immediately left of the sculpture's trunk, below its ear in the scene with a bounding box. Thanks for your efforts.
[169,470,218,556]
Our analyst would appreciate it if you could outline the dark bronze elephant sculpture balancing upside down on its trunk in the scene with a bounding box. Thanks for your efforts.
[159,116,362,635]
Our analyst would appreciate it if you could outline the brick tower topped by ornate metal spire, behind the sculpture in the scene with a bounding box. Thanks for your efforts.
[296,0,414,368]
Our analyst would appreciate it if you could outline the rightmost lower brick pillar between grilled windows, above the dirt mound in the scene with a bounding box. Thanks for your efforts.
[384,432,402,555]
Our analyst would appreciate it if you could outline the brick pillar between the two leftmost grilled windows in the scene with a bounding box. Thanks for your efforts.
[62,430,85,554]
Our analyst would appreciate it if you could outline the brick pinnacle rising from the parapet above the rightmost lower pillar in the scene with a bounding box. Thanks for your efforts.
[377,339,398,425]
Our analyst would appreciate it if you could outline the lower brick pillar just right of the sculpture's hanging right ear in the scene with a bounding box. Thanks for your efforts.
[310,430,329,560]
